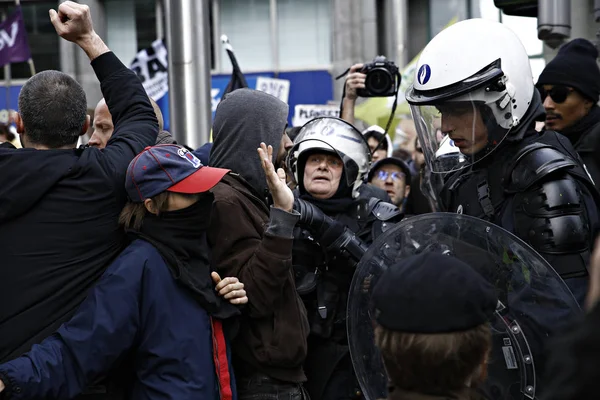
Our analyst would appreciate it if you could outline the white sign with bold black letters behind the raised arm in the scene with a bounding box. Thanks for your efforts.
[130,39,169,100]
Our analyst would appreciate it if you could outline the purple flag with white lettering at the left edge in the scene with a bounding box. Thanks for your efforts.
[0,7,31,67]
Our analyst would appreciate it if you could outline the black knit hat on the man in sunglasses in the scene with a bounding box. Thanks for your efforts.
[537,39,600,102]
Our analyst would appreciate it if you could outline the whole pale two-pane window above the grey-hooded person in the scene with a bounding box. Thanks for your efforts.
[219,0,331,72]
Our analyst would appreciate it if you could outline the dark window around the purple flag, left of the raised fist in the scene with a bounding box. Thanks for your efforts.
[0,1,60,80]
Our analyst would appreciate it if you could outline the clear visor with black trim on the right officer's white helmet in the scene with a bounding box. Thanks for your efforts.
[406,60,519,173]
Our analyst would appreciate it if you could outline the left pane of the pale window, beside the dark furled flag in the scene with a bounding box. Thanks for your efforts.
[217,0,273,72]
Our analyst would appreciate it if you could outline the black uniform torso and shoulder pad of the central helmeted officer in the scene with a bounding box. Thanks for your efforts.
[292,191,402,400]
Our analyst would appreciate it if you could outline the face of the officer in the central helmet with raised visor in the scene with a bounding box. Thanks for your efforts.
[304,153,344,199]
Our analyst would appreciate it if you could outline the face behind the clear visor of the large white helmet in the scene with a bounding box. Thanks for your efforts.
[436,102,488,155]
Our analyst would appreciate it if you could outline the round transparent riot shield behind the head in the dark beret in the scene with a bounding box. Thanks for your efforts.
[348,213,580,400]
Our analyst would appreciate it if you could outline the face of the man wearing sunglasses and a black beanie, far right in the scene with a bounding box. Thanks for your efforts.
[539,85,593,132]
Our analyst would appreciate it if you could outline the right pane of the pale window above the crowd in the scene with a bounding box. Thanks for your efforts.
[277,0,331,68]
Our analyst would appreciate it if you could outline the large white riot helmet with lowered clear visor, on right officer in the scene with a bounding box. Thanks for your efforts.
[406,19,534,172]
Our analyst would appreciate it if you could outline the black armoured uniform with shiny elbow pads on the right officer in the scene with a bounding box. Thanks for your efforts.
[440,91,600,304]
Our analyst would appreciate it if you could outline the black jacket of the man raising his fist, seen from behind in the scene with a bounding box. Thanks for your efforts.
[0,53,158,362]
